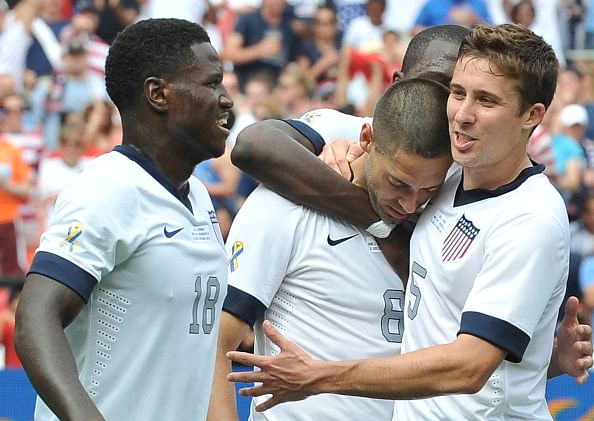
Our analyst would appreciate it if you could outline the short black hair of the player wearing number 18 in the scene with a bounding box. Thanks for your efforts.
[105,19,210,111]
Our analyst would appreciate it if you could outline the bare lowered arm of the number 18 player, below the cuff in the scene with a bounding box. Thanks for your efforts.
[15,274,103,421]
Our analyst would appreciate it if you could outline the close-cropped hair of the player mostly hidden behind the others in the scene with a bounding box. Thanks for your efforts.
[402,25,469,84]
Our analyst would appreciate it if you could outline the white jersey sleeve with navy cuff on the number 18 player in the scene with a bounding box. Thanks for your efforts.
[29,159,146,300]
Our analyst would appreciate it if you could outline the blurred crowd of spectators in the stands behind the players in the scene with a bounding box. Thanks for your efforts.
[0,0,594,366]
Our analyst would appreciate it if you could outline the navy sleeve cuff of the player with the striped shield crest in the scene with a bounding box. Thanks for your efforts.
[458,311,530,363]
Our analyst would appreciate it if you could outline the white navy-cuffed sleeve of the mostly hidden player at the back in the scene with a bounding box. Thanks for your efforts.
[285,108,372,154]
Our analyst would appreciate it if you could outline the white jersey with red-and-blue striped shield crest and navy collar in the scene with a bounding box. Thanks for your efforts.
[394,165,569,421]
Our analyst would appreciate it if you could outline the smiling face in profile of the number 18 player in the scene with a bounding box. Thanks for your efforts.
[167,42,233,162]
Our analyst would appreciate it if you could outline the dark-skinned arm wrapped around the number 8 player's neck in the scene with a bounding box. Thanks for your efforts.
[231,120,379,228]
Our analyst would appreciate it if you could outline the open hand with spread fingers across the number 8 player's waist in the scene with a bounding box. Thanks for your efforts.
[227,321,316,412]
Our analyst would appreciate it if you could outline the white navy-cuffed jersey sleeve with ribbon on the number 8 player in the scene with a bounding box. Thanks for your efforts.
[223,186,304,325]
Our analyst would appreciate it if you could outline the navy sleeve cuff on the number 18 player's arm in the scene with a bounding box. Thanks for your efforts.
[29,251,97,303]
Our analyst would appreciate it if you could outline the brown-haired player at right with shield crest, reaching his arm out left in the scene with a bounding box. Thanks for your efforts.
[229,24,591,419]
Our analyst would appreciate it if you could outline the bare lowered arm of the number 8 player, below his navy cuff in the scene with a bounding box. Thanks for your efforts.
[207,311,250,421]
